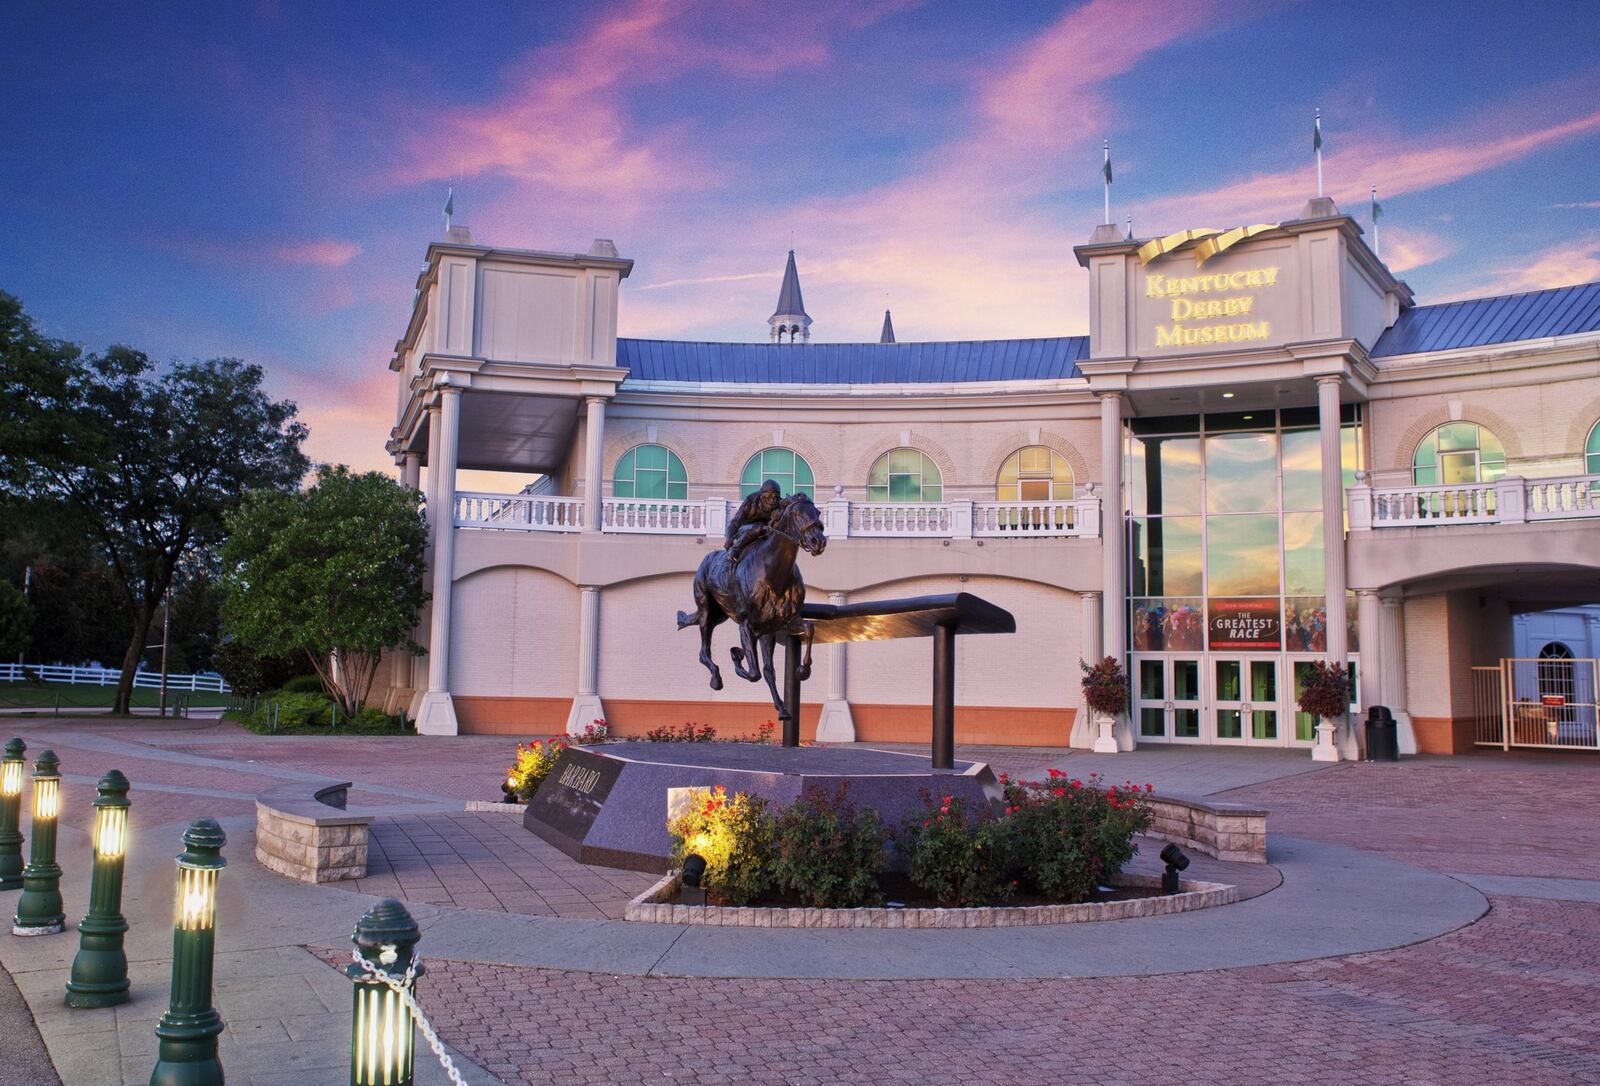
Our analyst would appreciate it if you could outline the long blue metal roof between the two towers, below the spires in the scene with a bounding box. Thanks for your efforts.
[616,336,1090,384]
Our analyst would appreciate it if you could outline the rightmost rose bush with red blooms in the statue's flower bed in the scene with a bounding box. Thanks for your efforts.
[1002,769,1150,902]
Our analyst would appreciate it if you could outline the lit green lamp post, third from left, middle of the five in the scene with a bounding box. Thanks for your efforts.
[67,769,128,1008]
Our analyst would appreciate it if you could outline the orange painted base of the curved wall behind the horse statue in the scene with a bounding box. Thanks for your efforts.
[454,696,1074,747]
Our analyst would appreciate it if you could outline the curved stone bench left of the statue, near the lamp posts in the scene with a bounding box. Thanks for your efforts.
[256,781,373,883]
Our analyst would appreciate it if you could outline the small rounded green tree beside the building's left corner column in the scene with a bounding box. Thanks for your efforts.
[222,465,427,715]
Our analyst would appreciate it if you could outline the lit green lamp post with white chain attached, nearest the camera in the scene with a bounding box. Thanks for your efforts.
[344,899,422,1086]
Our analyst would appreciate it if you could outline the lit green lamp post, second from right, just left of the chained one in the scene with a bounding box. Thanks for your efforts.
[150,819,227,1086]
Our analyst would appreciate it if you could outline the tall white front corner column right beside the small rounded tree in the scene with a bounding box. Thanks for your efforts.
[416,385,461,736]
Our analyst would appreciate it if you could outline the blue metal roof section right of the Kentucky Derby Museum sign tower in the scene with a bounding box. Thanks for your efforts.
[1373,283,1600,358]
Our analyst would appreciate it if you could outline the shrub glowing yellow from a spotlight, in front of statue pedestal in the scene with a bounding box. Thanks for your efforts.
[667,784,774,905]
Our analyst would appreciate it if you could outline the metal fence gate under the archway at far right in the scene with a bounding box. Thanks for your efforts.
[1472,657,1600,750]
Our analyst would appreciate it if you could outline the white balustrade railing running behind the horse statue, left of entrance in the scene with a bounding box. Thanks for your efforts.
[456,493,1101,539]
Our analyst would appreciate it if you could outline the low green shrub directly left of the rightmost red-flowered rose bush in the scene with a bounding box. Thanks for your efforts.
[898,793,1016,907]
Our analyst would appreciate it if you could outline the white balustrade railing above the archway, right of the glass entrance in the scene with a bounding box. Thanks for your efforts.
[1346,475,1600,531]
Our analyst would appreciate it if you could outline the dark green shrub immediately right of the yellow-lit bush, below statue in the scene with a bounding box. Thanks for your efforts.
[773,782,888,908]
